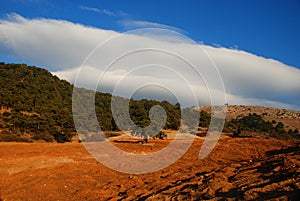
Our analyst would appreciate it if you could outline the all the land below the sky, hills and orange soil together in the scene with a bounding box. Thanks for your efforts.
[0,63,300,201]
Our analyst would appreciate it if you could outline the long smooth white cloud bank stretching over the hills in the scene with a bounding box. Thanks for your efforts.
[0,14,300,110]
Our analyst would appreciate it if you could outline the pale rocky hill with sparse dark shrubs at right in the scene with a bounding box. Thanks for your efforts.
[198,105,300,139]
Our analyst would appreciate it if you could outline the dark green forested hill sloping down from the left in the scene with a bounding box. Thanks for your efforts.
[0,62,180,142]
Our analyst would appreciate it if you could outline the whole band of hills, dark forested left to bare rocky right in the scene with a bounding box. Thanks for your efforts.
[0,62,300,142]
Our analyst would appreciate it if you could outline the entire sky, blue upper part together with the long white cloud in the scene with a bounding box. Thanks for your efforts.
[0,0,300,110]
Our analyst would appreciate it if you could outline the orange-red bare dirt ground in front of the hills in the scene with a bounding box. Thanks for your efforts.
[0,137,300,201]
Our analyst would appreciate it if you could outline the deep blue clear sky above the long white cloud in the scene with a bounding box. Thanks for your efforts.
[0,0,300,68]
